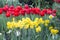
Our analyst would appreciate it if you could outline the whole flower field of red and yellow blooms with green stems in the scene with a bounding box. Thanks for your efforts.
[0,0,60,40]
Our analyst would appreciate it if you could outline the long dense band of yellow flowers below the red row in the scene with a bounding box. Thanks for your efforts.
[7,17,50,32]
